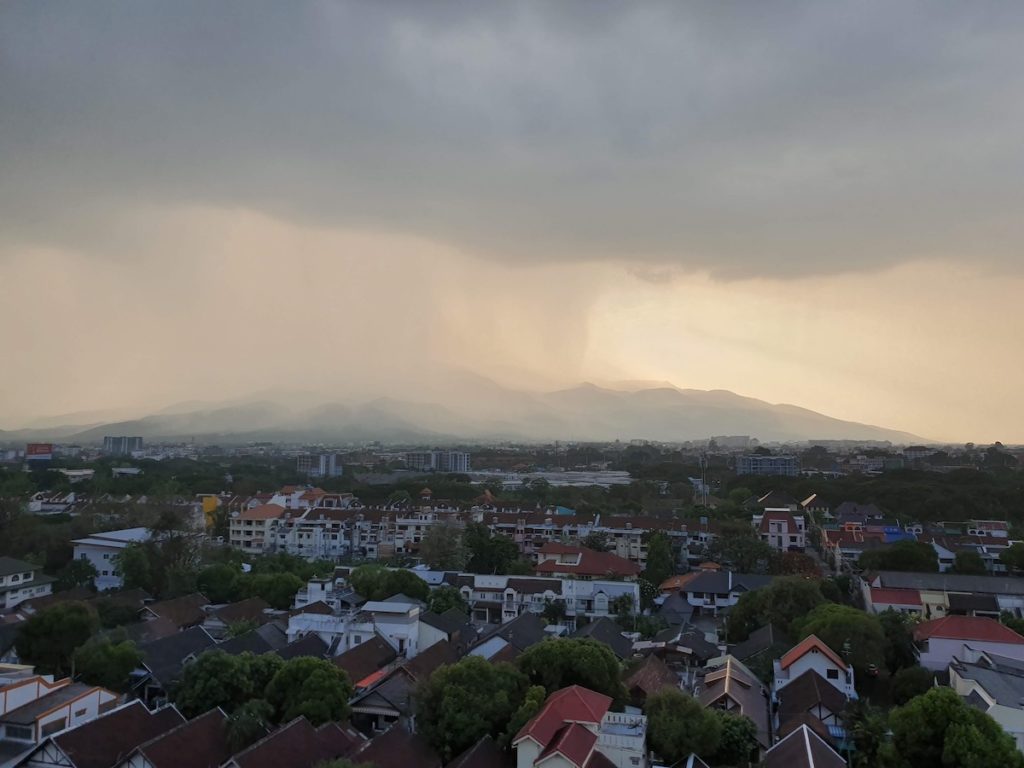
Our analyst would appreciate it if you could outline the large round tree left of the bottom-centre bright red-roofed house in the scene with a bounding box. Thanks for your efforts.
[414,655,528,763]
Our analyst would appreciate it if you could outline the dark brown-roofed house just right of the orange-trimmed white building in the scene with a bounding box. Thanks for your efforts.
[11,699,185,768]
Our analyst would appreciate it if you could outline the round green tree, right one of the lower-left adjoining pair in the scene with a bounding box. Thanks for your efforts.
[264,656,354,725]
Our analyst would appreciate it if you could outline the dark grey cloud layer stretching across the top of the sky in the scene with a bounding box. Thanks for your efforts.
[0,0,1024,278]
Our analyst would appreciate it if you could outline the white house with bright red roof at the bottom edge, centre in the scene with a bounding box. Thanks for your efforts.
[512,685,647,768]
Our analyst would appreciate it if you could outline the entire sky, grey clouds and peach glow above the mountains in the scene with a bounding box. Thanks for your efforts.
[0,0,1024,442]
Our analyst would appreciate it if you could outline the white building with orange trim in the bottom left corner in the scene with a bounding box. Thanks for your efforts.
[0,675,121,764]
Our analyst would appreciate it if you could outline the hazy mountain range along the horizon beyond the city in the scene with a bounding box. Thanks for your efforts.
[0,376,922,443]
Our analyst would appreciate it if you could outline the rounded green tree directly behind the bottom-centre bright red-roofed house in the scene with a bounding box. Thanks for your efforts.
[516,637,626,700]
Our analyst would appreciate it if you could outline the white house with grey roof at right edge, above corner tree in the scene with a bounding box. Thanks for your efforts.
[948,646,1024,752]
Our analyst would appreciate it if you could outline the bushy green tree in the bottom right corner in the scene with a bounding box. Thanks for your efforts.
[889,688,1024,768]
